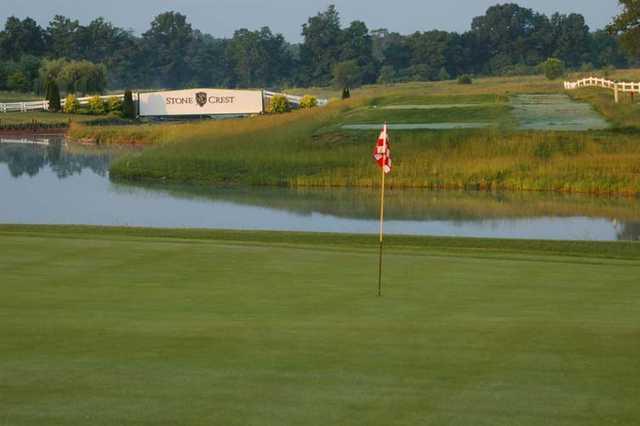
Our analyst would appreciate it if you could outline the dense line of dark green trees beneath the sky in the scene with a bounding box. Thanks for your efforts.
[0,1,638,94]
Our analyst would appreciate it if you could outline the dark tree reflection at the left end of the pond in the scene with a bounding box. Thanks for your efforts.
[0,139,111,179]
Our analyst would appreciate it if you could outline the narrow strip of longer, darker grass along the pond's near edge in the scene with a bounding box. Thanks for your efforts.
[0,224,640,260]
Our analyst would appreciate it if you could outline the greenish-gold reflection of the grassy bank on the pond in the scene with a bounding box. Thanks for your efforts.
[109,184,640,221]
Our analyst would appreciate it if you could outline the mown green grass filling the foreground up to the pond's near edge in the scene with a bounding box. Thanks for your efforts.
[0,226,640,426]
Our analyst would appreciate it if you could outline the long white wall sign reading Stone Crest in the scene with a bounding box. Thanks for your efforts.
[140,89,263,117]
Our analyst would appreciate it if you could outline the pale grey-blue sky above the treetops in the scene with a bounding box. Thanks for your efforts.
[0,0,618,41]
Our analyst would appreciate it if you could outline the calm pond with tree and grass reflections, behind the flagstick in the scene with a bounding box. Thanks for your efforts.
[0,140,640,240]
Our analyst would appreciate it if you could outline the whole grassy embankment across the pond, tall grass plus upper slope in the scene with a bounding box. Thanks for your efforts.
[70,79,640,195]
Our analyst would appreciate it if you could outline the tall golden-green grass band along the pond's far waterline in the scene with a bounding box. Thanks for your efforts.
[105,123,640,194]
